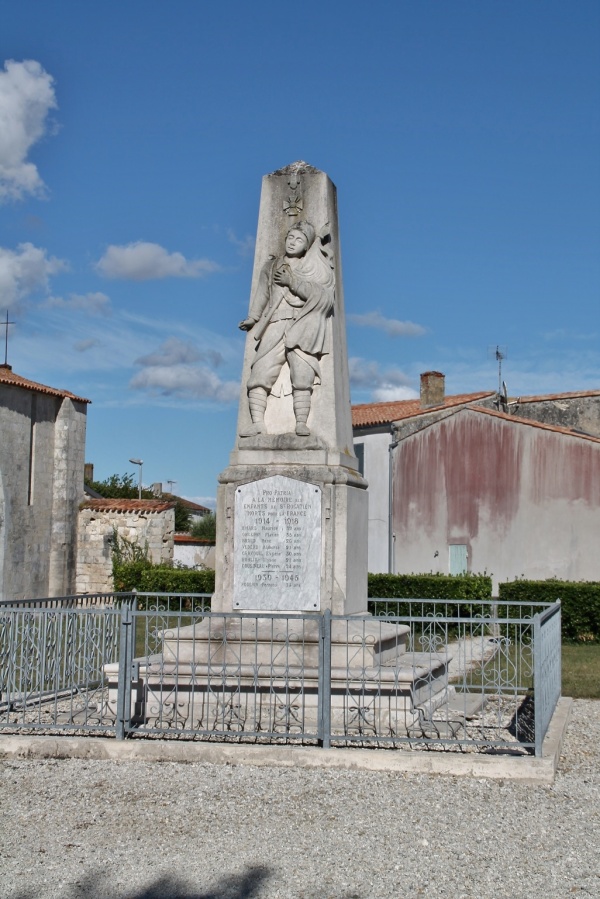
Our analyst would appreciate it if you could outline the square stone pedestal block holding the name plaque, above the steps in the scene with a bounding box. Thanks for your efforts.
[212,460,367,615]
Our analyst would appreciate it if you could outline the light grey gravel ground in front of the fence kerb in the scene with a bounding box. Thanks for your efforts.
[0,700,600,899]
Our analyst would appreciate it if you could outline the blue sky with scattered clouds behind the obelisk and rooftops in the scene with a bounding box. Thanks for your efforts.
[0,0,600,505]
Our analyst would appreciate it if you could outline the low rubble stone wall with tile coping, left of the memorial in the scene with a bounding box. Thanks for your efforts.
[76,508,175,593]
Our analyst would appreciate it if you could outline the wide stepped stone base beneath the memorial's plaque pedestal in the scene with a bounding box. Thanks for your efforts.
[107,616,450,739]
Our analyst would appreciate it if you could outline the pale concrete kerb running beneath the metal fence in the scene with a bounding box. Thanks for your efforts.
[0,697,573,784]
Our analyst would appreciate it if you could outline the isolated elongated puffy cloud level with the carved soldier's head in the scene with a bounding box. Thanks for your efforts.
[96,240,219,281]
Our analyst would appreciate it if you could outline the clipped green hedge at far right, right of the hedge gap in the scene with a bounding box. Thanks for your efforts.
[498,580,600,643]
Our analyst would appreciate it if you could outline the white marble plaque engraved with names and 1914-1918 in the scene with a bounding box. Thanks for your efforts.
[233,475,321,612]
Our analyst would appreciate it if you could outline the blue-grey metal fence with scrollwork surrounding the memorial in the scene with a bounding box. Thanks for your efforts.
[0,593,561,755]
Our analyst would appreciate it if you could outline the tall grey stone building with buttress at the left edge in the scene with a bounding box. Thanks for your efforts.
[0,364,89,600]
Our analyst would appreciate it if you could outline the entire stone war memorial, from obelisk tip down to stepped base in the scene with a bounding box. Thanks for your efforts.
[123,162,447,733]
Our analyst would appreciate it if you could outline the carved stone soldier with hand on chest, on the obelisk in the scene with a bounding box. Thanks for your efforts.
[239,222,335,437]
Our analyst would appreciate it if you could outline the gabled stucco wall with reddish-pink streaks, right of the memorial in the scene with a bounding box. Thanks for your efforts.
[393,409,600,586]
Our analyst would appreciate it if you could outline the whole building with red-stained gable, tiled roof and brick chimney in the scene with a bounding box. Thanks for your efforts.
[353,372,600,586]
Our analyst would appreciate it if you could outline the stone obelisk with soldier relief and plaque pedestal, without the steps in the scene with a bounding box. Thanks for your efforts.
[213,162,367,614]
